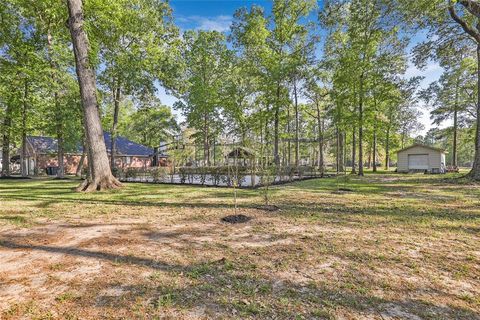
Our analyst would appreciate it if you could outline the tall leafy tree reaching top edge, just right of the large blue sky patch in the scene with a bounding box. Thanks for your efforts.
[232,0,316,165]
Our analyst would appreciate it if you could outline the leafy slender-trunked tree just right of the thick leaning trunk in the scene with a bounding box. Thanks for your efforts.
[86,0,178,168]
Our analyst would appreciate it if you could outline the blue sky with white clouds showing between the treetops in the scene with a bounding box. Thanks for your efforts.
[158,0,442,134]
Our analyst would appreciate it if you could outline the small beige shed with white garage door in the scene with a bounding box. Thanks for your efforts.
[397,144,446,173]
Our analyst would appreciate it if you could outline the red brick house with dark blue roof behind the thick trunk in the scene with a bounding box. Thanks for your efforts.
[19,132,167,175]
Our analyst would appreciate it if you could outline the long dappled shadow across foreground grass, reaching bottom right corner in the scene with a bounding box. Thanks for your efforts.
[0,235,480,320]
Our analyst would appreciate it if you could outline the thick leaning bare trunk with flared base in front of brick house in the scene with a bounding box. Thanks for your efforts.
[67,0,121,191]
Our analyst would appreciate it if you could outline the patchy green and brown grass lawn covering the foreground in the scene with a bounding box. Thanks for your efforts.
[0,173,480,320]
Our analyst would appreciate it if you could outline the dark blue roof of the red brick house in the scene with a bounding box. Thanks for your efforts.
[27,132,158,157]
